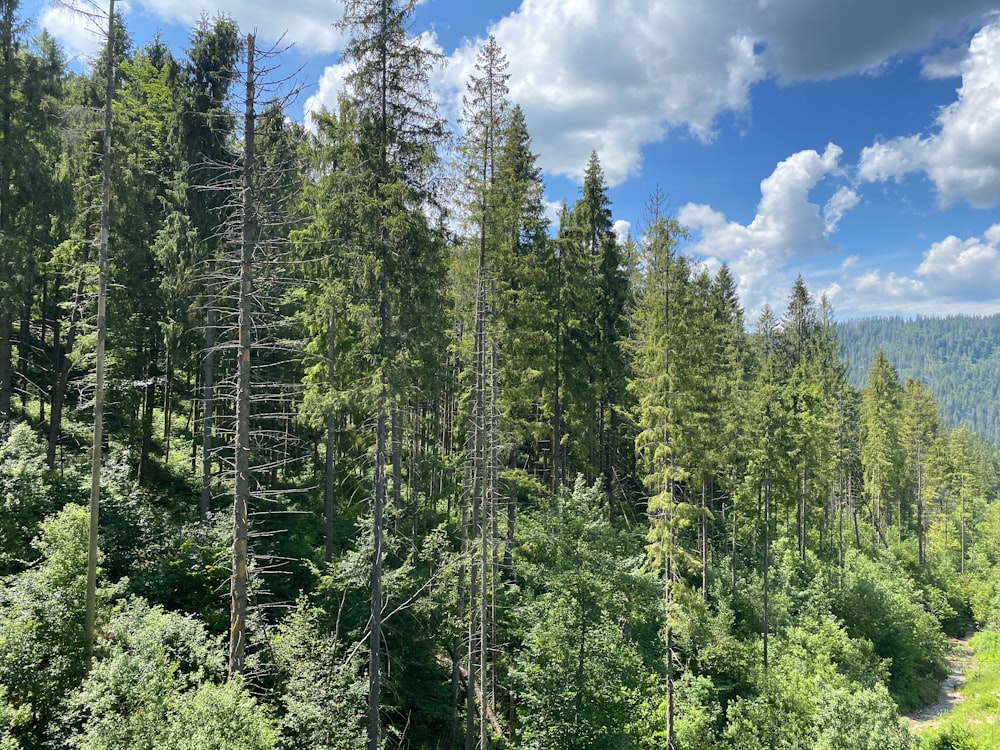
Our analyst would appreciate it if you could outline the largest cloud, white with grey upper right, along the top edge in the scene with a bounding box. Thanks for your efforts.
[440,0,995,185]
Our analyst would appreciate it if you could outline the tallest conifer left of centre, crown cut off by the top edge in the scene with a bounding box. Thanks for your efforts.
[342,0,443,750]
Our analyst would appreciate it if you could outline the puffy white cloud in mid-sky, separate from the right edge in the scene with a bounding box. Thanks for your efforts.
[677,143,859,313]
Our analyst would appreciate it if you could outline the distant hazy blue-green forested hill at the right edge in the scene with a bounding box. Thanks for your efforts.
[837,315,1000,445]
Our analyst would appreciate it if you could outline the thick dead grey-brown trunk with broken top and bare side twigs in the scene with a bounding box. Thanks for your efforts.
[229,34,256,679]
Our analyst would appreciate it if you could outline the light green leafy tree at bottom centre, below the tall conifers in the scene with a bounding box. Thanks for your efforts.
[511,480,656,749]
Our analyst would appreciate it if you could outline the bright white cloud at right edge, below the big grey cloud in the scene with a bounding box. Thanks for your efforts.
[858,21,1000,208]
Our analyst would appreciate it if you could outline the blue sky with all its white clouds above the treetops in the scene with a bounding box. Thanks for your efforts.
[21,0,1000,319]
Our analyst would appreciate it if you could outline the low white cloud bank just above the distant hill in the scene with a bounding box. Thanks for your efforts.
[830,224,1000,315]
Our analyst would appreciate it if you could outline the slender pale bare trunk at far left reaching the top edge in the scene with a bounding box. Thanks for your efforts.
[84,0,115,672]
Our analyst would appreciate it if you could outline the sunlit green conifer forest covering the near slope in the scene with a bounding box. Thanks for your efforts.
[0,0,1000,750]
